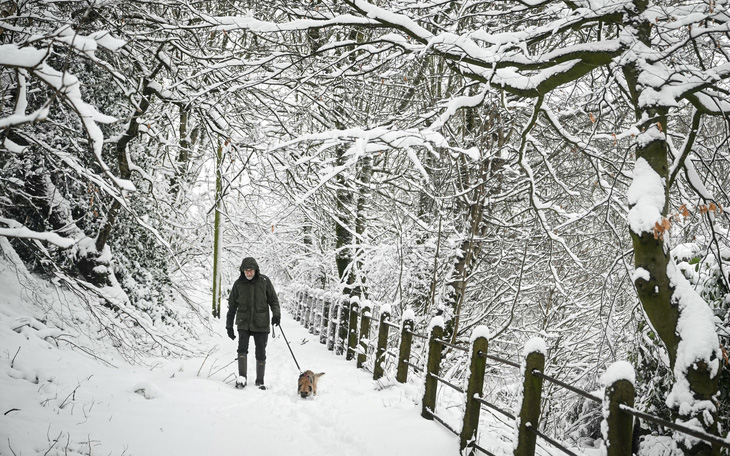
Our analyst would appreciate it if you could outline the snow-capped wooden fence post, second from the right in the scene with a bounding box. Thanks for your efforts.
[514,337,547,456]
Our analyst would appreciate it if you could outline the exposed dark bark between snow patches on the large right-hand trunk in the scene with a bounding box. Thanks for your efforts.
[624,4,721,448]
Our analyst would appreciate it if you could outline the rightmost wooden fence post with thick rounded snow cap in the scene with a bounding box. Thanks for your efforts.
[601,361,636,456]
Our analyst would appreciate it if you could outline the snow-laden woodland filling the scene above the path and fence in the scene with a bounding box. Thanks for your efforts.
[0,0,730,452]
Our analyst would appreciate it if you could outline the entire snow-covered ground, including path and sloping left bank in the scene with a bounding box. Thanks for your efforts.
[0,238,670,456]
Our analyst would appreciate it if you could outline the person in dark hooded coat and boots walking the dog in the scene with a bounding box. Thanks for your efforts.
[226,257,281,389]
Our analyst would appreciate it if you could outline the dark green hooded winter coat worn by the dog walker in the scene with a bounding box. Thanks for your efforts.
[226,257,281,332]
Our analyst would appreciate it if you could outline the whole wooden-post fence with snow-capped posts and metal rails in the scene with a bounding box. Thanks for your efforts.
[291,288,730,456]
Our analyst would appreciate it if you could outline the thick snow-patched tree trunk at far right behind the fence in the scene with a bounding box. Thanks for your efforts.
[624,1,721,448]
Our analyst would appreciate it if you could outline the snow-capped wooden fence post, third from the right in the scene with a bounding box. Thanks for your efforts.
[459,326,489,455]
